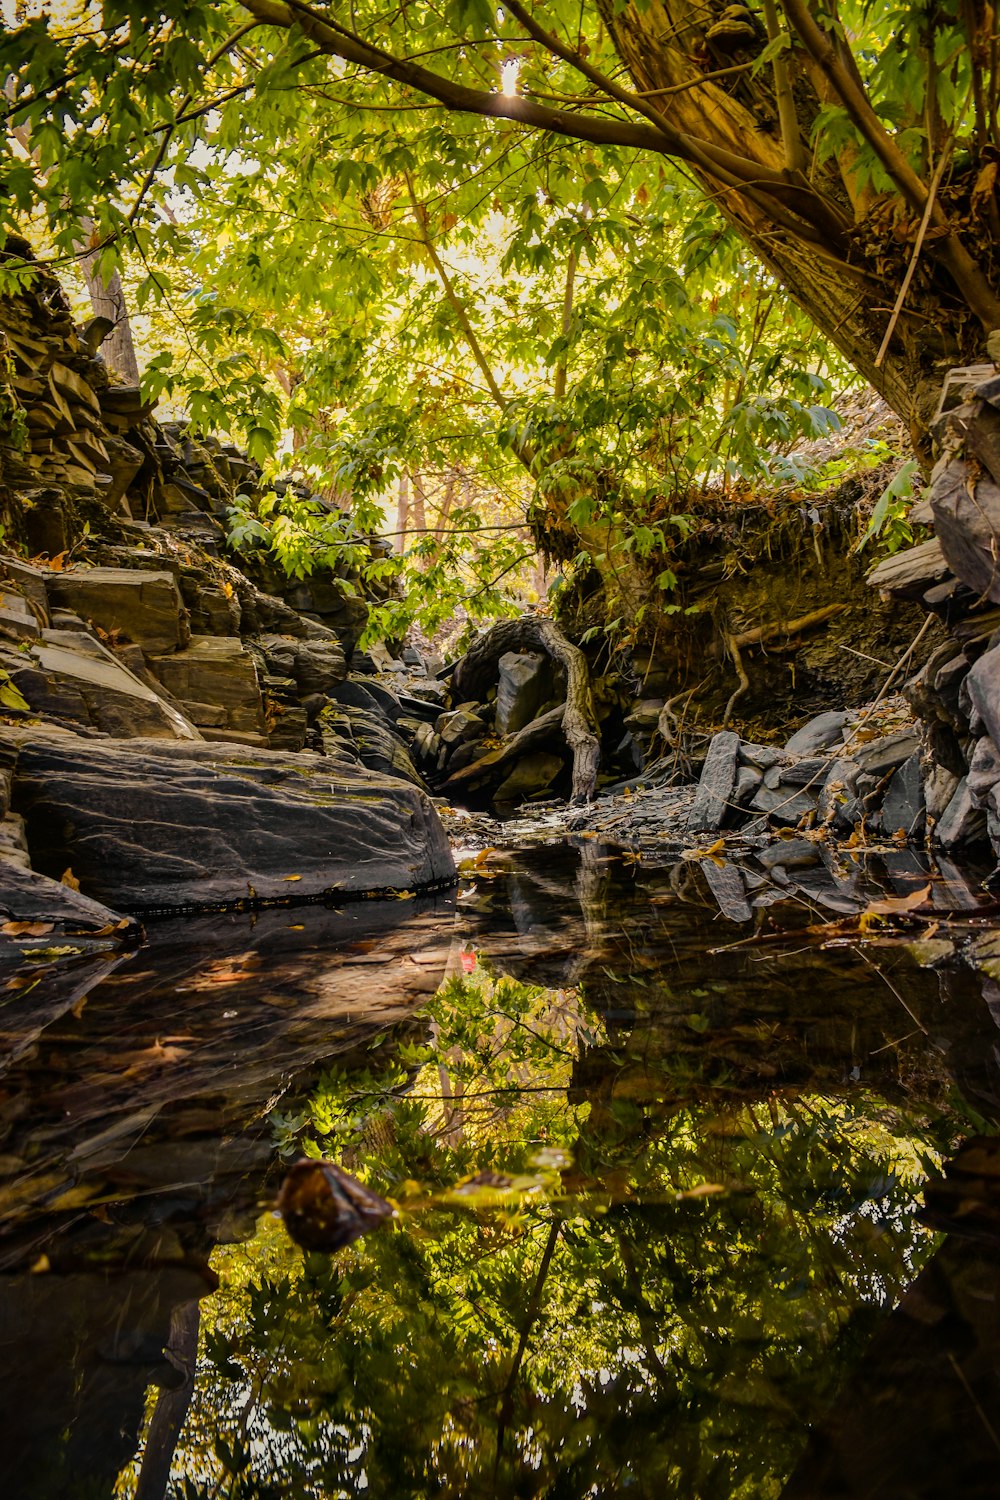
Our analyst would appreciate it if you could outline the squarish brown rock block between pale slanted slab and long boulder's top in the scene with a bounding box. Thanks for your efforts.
[150,636,267,746]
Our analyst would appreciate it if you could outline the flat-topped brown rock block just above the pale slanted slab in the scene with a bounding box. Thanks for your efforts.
[46,567,187,654]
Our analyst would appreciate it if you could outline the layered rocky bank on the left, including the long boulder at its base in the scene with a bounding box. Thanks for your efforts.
[0,245,453,932]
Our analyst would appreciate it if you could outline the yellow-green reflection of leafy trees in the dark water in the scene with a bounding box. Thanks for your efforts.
[118,960,955,1500]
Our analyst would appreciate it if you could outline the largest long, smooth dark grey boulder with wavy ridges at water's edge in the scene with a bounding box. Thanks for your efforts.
[4,731,454,912]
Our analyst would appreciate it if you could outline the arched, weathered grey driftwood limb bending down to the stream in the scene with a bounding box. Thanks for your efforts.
[451,615,601,801]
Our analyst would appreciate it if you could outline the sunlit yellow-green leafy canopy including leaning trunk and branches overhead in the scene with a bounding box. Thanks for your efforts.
[0,0,983,624]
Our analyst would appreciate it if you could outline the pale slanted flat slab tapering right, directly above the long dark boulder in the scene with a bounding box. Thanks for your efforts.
[0,630,199,740]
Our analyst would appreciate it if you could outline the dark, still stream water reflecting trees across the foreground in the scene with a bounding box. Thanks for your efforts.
[0,840,1000,1500]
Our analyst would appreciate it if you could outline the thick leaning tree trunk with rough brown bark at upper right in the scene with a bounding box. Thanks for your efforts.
[600,0,1000,437]
